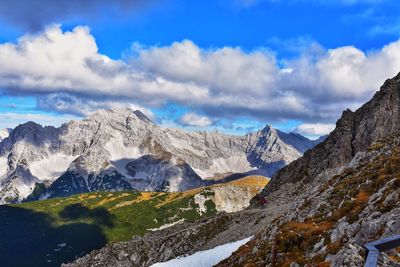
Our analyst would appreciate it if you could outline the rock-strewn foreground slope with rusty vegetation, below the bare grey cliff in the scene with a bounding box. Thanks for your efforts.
[219,133,400,266]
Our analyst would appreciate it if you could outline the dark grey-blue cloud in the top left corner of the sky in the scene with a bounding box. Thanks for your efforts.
[0,0,156,30]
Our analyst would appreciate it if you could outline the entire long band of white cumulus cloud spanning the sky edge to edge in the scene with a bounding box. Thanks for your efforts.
[0,26,400,129]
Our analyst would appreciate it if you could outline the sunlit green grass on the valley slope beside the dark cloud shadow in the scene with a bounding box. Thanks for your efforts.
[14,189,216,242]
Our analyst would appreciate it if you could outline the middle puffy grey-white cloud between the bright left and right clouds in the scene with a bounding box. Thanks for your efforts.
[131,40,279,97]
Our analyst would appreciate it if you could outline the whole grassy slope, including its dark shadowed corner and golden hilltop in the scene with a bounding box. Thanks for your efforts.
[0,176,267,266]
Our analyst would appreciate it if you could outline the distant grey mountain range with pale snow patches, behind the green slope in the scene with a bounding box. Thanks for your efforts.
[0,109,315,204]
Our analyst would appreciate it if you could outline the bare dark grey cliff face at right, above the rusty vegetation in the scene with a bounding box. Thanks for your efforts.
[263,74,400,196]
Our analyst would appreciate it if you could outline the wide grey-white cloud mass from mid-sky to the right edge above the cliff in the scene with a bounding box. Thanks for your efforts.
[131,35,400,120]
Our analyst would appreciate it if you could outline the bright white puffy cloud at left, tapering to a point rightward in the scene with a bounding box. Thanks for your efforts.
[0,26,207,102]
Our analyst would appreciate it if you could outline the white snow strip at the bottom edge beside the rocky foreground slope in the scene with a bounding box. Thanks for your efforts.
[151,236,252,267]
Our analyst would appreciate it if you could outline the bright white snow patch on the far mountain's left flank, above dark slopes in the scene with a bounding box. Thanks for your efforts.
[29,152,77,181]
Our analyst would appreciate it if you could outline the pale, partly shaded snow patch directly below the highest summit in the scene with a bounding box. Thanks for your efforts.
[104,133,142,178]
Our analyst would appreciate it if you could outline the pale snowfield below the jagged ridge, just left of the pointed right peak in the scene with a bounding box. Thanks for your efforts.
[193,153,256,179]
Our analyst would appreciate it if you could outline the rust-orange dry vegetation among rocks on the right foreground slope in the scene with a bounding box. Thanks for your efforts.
[220,137,400,266]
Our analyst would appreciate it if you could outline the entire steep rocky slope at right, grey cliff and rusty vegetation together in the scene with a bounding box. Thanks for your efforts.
[220,74,400,266]
